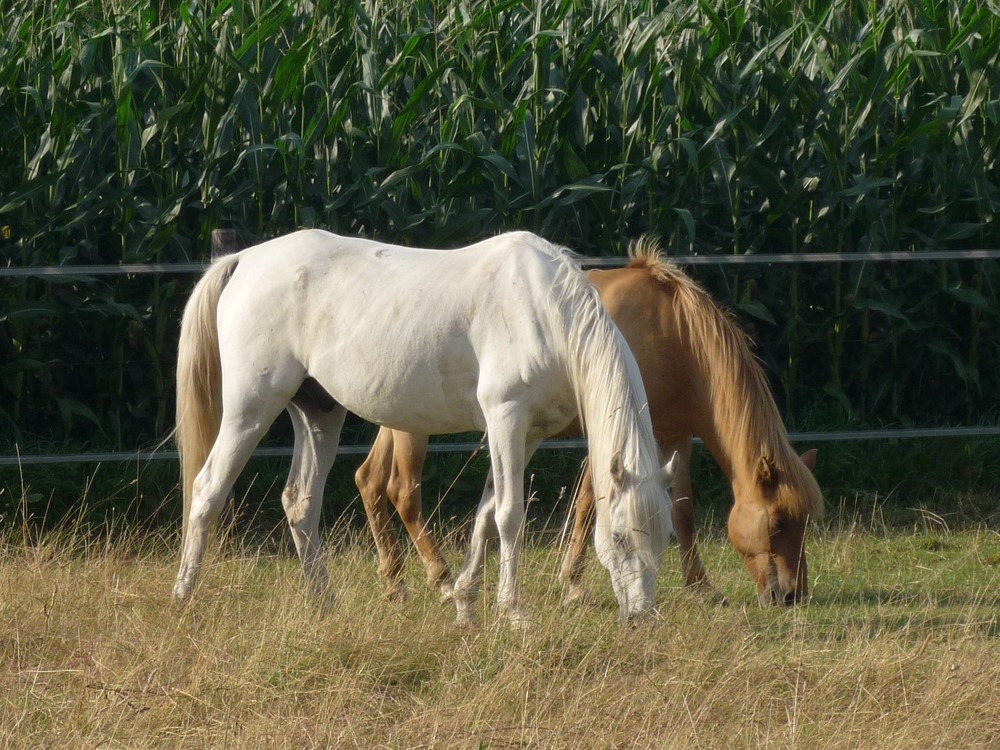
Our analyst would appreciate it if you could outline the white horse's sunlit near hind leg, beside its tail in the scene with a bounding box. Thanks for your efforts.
[174,414,274,599]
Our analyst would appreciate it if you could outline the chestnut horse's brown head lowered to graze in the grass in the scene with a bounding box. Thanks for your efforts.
[729,450,823,606]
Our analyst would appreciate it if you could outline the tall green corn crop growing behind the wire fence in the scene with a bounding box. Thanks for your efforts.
[0,0,1000,462]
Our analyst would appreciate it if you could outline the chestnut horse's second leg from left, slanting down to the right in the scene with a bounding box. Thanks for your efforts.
[388,431,452,599]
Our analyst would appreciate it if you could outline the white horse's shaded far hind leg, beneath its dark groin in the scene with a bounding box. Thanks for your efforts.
[281,403,347,598]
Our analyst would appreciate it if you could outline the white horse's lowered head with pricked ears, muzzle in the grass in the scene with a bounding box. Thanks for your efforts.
[594,452,679,622]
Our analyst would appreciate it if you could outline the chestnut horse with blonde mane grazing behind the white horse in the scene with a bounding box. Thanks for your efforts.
[356,242,823,605]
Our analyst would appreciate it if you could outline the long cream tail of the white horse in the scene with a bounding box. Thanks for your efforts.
[176,255,239,536]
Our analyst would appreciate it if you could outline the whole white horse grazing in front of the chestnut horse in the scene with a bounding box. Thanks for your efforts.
[174,230,675,622]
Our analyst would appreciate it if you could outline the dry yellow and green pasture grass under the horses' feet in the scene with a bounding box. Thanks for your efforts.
[0,513,1000,750]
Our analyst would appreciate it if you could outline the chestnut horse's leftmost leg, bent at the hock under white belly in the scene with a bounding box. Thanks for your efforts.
[354,427,403,596]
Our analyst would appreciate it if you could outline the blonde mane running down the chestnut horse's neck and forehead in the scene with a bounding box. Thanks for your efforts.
[629,237,823,518]
